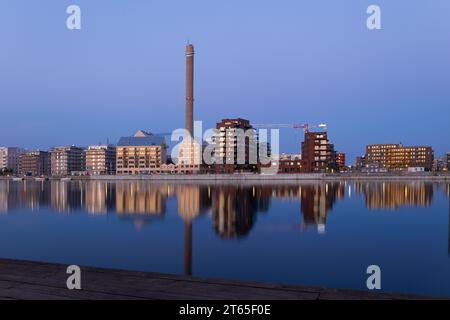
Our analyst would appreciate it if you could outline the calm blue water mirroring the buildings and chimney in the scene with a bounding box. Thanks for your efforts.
[0,181,450,296]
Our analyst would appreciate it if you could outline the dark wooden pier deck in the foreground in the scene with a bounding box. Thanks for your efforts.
[0,259,440,300]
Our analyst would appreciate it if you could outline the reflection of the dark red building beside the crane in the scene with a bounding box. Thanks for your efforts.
[300,183,345,232]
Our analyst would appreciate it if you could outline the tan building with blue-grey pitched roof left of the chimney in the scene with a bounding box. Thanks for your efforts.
[116,130,167,175]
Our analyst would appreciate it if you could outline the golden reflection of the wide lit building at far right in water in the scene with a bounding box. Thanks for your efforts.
[355,182,433,209]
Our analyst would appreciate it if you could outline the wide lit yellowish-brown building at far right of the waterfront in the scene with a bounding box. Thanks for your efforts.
[366,144,434,171]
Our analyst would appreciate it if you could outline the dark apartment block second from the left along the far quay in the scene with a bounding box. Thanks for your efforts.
[19,150,51,177]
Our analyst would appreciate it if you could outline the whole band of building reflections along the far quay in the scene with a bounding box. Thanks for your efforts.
[0,180,442,232]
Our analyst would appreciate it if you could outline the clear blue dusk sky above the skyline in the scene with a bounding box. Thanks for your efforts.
[0,0,450,161]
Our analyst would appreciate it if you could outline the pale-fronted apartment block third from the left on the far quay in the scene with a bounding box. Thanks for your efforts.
[50,146,86,177]
